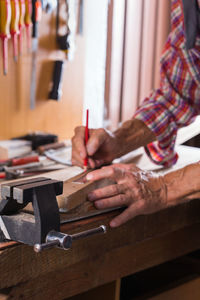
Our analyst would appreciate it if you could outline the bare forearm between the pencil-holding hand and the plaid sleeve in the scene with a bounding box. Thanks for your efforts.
[114,119,156,157]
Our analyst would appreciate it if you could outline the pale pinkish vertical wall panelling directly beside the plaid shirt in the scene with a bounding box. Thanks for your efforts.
[114,0,171,123]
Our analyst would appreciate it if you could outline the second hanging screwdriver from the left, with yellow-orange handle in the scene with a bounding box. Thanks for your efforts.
[10,0,19,62]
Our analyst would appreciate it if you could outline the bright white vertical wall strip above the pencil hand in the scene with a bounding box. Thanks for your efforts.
[83,0,109,128]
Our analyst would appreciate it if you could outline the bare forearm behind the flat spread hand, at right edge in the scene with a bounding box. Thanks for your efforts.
[163,162,200,206]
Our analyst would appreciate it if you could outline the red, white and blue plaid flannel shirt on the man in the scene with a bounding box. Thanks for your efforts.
[134,0,200,167]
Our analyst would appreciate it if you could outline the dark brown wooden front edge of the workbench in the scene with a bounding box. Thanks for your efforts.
[0,200,200,299]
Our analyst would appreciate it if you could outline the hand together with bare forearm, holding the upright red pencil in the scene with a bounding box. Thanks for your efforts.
[72,119,155,168]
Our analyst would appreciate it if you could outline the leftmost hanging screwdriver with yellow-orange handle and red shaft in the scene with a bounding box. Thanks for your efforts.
[0,0,11,75]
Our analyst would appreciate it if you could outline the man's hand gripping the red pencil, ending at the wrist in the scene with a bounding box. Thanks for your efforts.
[72,126,119,168]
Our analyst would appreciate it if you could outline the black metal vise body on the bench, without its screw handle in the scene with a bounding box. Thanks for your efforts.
[0,177,63,245]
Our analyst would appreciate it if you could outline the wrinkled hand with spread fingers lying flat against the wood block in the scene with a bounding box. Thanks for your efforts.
[86,164,167,227]
